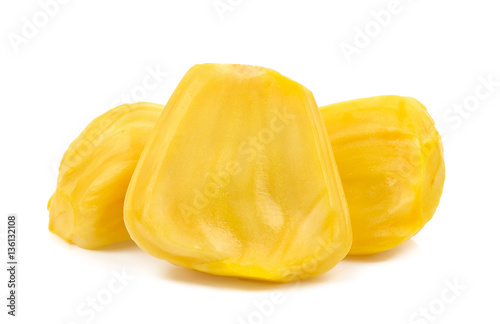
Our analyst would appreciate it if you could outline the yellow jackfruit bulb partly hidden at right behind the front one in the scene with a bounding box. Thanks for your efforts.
[320,96,445,255]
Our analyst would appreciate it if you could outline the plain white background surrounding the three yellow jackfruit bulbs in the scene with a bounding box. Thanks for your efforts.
[0,0,500,324]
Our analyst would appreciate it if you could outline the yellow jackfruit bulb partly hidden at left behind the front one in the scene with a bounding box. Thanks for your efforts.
[48,102,163,249]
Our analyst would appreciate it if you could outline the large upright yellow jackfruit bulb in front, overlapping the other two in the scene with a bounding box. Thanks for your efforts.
[124,64,352,282]
